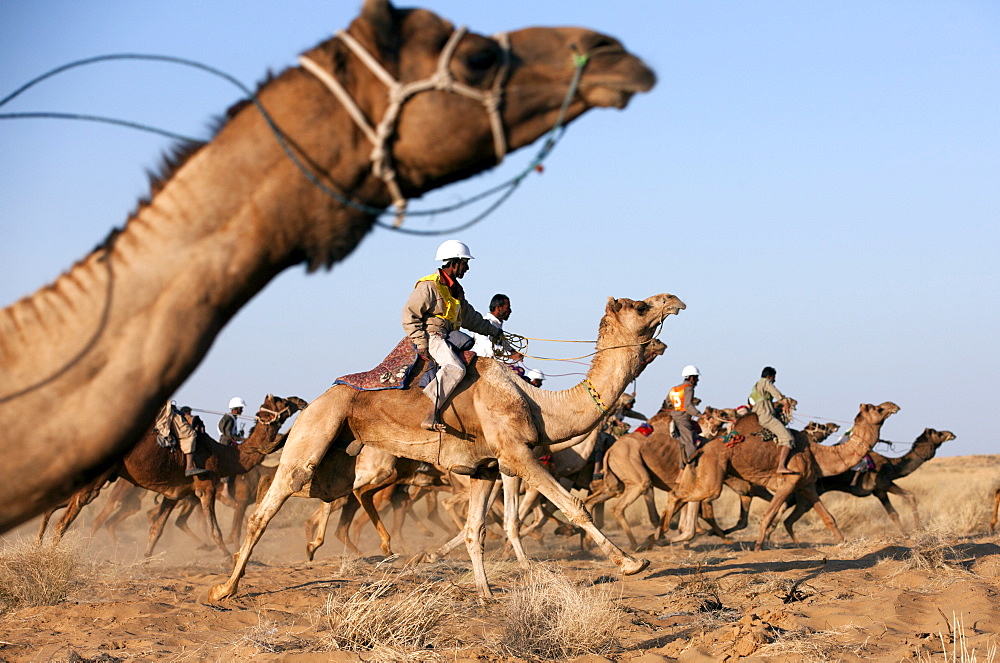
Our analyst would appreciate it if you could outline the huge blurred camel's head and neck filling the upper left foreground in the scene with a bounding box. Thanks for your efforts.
[0,0,656,533]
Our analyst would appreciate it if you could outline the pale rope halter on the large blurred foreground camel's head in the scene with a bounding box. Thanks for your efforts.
[299,26,510,227]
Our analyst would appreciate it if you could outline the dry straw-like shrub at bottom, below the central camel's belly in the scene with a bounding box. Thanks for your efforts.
[324,576,460,660]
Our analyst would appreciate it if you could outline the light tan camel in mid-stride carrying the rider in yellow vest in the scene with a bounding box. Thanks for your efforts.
[208,294,685,601]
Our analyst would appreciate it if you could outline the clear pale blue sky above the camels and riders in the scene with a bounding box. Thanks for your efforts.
[0,0,1000,456]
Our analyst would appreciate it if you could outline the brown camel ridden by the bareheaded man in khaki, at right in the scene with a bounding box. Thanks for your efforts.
[657,401,899,550]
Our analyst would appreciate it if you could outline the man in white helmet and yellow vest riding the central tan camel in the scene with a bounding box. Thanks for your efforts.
[403,239,501,431]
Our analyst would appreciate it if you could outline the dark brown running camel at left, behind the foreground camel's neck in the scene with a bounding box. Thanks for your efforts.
[39,394,306,558]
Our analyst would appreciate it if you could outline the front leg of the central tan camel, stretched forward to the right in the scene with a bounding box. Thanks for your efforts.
[508,444,649,575]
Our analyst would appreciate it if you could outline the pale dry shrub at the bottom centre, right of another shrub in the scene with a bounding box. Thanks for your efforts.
[496,564,625,659]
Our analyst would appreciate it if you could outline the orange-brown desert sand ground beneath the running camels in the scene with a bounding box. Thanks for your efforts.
[0,456,1000,663]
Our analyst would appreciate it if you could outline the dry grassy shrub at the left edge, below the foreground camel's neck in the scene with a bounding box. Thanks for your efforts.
[0,539,94,614]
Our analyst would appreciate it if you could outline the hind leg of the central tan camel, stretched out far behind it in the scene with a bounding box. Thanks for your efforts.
[208,387,353,602]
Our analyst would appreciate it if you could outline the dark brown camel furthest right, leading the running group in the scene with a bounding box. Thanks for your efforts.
[784,428,955,543]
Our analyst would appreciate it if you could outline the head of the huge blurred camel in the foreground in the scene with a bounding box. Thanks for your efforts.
[316,0,656,197]
